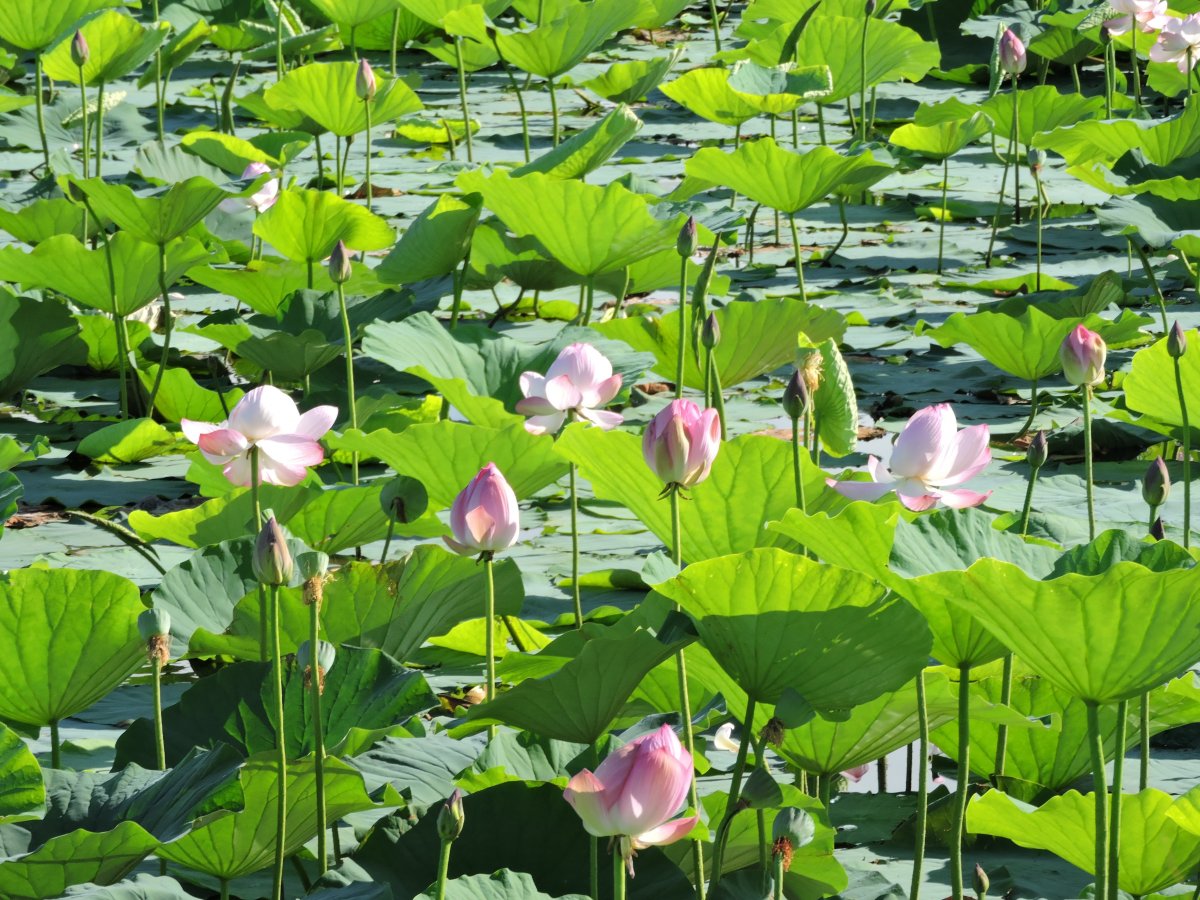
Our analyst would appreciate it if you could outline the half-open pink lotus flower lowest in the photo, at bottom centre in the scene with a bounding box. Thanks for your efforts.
[563,725,698,874]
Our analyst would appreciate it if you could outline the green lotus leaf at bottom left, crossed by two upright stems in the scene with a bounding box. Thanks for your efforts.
[157,754,374,880]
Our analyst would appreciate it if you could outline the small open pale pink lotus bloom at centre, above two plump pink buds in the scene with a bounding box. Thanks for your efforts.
[517,343,623,434]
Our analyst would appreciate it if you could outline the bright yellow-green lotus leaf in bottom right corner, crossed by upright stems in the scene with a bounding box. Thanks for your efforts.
[967,788,1200,896]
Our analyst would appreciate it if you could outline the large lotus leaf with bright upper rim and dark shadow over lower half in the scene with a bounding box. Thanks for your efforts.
[656,548,931,714]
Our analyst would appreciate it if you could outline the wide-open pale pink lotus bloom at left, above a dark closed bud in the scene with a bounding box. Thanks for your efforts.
[180,384,337,487]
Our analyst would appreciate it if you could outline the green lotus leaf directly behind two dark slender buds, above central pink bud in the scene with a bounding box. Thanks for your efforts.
[593,297,846,390]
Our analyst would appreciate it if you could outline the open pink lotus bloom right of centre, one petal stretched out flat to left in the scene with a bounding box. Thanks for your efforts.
[828,403,991,511]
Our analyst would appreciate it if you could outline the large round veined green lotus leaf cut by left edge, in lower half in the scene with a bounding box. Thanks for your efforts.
[0,569,145,725]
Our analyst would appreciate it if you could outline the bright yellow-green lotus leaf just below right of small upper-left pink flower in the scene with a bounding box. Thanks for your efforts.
[254,190,396,266]
